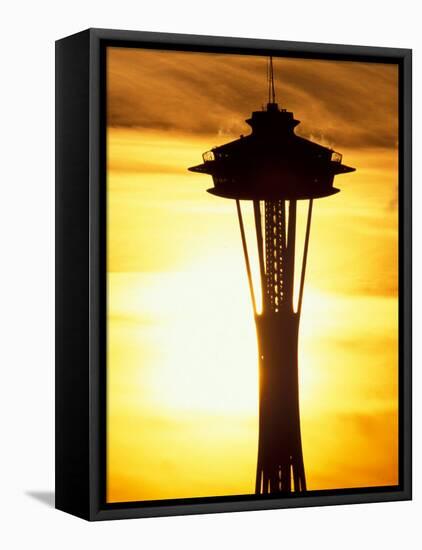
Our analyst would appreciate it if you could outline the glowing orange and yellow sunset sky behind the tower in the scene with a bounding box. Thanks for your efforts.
[107,48,398,502]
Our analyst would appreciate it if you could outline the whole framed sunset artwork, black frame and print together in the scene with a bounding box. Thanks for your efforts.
[56,29,411,520]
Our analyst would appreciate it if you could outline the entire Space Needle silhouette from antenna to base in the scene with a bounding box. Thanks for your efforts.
[189,57,355,495]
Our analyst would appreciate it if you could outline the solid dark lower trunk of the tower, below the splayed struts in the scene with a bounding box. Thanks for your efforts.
[255,308,306,494]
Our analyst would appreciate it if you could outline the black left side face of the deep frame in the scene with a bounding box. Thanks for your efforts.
[55,32,89,519]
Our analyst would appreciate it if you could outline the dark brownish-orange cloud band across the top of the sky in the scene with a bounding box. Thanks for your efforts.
[108,48,398,148]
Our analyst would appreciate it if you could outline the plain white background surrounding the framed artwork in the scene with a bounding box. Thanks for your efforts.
[0,0,422,550]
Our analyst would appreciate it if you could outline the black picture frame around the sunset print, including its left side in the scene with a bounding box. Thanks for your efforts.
[56,29,412,521]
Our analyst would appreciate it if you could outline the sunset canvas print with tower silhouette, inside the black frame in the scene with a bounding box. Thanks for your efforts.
[105,46,399,504]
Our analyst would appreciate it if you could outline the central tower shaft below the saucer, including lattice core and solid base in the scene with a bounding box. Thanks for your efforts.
[255,200,306,494]
